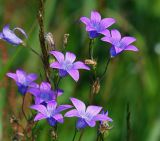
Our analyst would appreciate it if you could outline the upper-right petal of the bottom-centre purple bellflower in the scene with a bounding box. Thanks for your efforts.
[86,106,102,117]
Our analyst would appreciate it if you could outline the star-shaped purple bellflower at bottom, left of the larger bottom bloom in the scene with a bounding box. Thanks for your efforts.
[30,101,72,126]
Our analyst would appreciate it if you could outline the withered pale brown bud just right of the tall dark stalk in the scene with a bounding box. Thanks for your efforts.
[44,32,55,52]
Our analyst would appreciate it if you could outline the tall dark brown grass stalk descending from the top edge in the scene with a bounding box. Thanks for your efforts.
[38,0,50,82]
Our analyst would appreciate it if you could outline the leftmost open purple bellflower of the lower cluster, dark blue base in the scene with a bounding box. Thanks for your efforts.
[7,70,38,95]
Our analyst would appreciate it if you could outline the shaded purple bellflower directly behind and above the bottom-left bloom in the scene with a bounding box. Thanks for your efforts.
[28,82,63,104]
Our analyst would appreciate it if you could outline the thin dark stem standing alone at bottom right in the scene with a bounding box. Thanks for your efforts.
[126,103,131,141]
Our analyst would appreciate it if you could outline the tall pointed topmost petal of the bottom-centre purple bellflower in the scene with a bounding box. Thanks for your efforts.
[70,98,86,113]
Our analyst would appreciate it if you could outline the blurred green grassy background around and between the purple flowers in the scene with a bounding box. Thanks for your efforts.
[0,0,160,141]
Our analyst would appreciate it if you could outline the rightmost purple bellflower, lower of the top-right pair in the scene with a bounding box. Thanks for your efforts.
[101,29,138,57]
